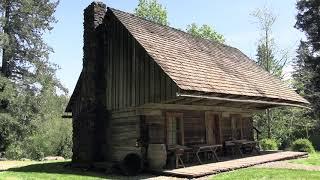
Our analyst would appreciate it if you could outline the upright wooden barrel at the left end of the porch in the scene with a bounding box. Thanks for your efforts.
[148,144,167,170]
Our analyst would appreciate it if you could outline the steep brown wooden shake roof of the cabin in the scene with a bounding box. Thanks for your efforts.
[108,8,309,105]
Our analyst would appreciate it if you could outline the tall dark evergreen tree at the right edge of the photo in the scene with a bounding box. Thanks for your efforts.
[295,0,320,119]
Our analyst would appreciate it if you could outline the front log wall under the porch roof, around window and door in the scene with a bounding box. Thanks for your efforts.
[145,110,253,145]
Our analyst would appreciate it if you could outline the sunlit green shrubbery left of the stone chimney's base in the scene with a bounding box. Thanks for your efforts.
[5,119,72,160]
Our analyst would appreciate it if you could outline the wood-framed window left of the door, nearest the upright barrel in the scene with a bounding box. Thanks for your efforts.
[167,113,184,145]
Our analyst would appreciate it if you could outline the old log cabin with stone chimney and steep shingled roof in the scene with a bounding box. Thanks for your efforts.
[66,2,309,174]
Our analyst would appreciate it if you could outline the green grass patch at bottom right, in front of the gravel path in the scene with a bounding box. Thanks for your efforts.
[211,168,320,180]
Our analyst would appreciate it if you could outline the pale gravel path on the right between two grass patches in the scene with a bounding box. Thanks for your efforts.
[254,161,320,171]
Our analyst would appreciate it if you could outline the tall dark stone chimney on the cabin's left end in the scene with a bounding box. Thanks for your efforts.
[72,2,106,163]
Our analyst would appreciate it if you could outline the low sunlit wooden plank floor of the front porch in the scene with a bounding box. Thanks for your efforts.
[153,151,308,178]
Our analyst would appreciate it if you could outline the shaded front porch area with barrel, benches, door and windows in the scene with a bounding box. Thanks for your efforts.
[139,107,260,169]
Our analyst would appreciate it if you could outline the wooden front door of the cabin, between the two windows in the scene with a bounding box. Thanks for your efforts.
[205,113,221,144]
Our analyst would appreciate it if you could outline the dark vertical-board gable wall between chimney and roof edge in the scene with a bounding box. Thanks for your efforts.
[105,12,178,110]
